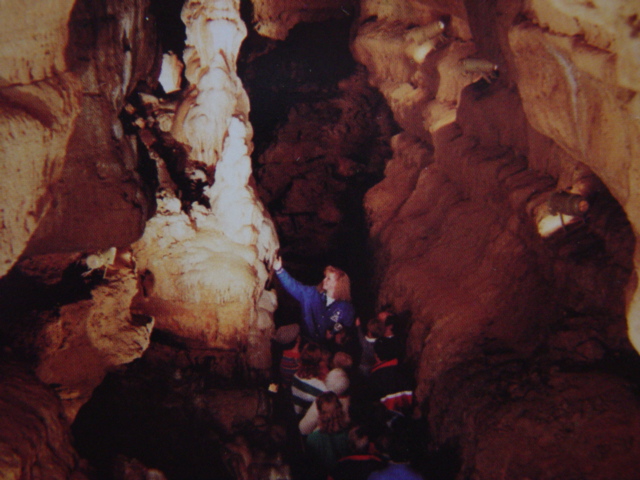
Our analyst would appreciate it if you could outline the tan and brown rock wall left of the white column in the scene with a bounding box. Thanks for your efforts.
[1,1,156,421]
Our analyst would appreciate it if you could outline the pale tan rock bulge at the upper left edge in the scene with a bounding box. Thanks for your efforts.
[0,1,80,275]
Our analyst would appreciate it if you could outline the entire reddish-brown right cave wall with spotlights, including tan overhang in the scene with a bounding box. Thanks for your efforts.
[353,0,640,478]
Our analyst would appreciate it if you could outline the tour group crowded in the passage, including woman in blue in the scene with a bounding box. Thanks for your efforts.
[274,257,423,480]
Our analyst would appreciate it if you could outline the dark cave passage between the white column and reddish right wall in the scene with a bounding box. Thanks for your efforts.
[238,18,398,323]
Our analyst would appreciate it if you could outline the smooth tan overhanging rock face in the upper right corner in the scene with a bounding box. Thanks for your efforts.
[508,1,640,349]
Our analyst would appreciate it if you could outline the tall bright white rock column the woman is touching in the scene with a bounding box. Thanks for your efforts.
[134,0,278,373]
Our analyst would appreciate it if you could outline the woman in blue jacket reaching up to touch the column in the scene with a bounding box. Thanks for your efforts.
[273,257,355,343]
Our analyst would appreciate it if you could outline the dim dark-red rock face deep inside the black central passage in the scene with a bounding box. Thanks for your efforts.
[256,68,395,267]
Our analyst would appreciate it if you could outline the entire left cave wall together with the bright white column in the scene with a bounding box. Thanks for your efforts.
[0,0,278,479]
